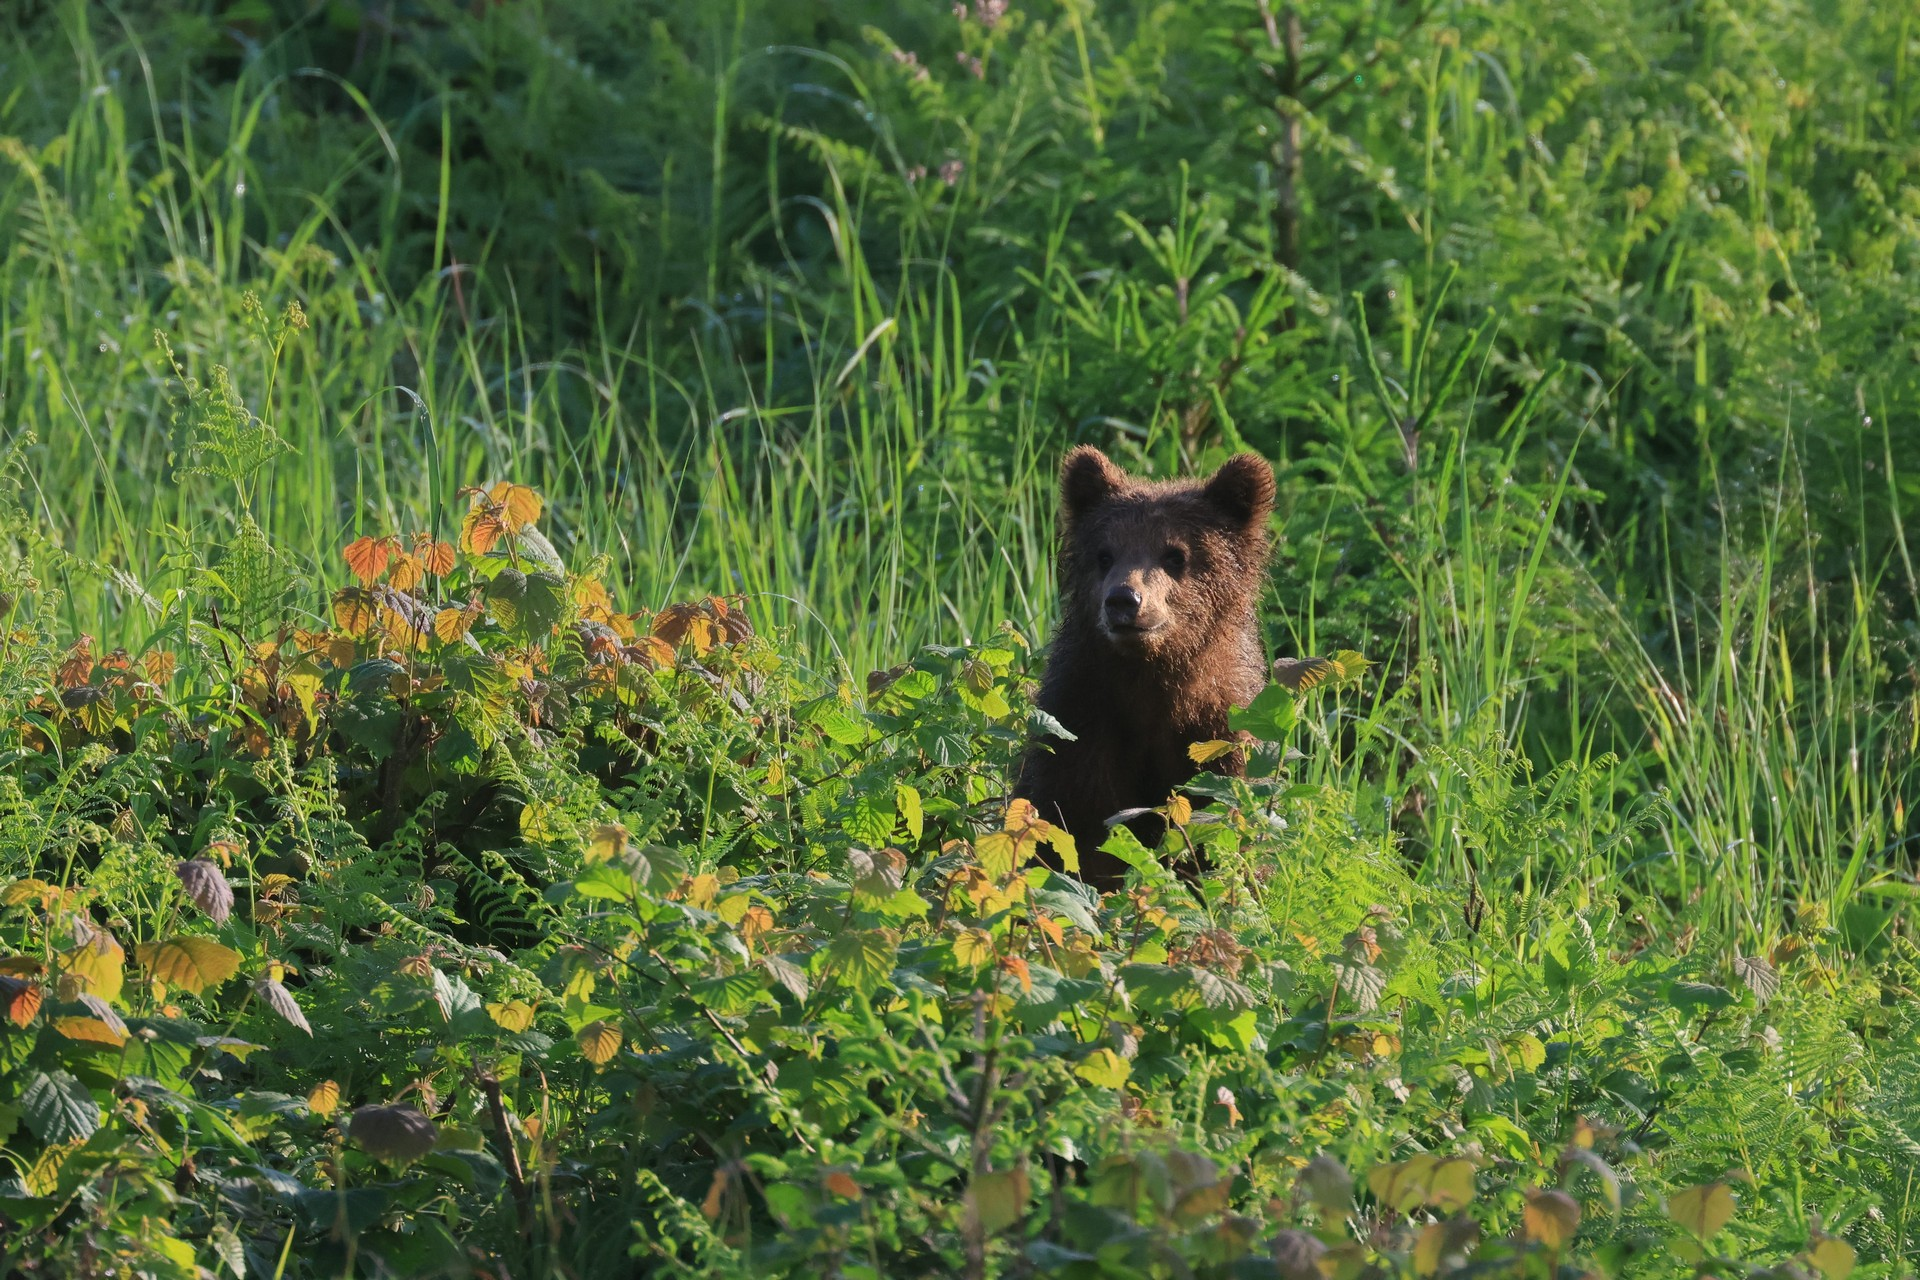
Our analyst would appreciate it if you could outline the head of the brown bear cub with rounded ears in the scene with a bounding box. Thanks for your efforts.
[1060,445,1273,660]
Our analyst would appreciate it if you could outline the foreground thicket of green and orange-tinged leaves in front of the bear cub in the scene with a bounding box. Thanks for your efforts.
[0,484,1914,1276]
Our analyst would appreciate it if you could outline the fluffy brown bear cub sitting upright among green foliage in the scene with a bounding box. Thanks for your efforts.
[1014,445,1273,887]
